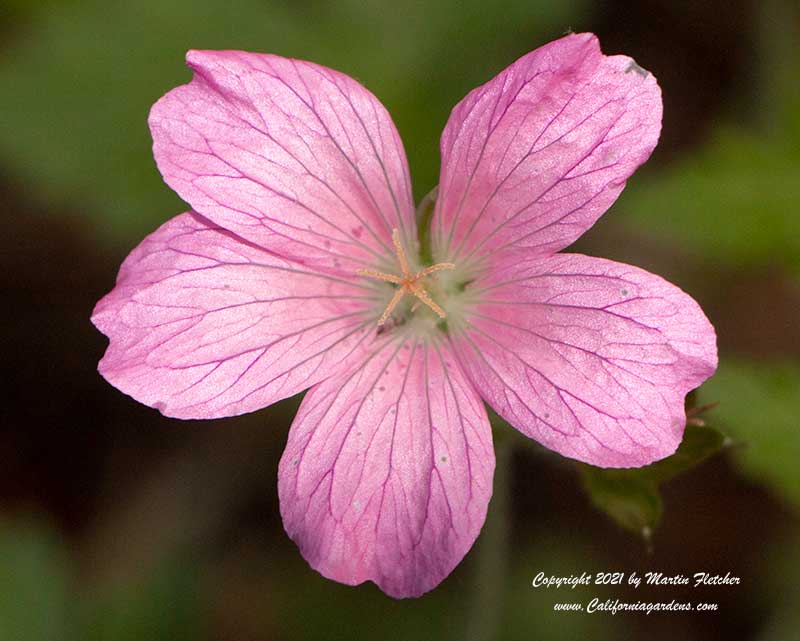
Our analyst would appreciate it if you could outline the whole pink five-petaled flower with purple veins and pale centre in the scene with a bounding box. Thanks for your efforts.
[93,34,717,597]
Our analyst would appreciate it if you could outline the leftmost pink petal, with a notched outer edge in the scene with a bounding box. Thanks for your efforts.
[92,213,374,418]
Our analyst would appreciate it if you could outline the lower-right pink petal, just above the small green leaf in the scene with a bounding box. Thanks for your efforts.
[459,254,717,467]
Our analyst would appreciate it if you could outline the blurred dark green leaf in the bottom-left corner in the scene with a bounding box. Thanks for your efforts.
[0,521,74,641]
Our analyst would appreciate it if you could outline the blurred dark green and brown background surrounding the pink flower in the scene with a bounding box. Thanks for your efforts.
[0,0,800,641]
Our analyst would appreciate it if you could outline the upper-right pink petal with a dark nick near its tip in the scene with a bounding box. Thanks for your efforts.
[433,33,661,262]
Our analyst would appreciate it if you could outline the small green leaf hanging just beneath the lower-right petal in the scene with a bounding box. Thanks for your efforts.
[580,425,728,539]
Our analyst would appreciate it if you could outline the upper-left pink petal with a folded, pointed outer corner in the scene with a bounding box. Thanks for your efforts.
[150,51,416,272]
